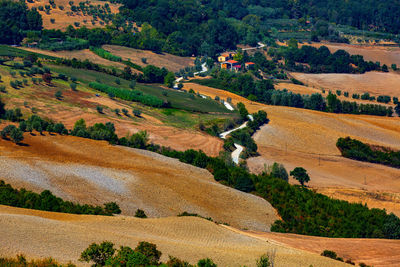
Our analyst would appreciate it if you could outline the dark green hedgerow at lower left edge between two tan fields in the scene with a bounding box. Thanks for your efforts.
[0,181,119,215]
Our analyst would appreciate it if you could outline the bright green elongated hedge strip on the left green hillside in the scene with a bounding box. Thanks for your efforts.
[89,82,164,107]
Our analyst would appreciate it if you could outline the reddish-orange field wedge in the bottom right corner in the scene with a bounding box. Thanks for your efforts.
[245,231,400,267]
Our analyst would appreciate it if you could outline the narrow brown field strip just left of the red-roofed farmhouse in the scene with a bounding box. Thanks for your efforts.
[103,45,194,72]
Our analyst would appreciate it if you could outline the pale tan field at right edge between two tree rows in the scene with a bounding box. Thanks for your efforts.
[291,71,400,97]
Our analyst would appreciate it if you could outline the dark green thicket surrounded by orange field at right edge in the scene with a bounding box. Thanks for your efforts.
[336,137,400,168]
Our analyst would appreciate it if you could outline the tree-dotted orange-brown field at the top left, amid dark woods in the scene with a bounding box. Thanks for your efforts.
[26,0,120,30]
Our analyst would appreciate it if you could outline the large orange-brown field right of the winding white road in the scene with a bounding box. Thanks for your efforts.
[185,83,400,215]
